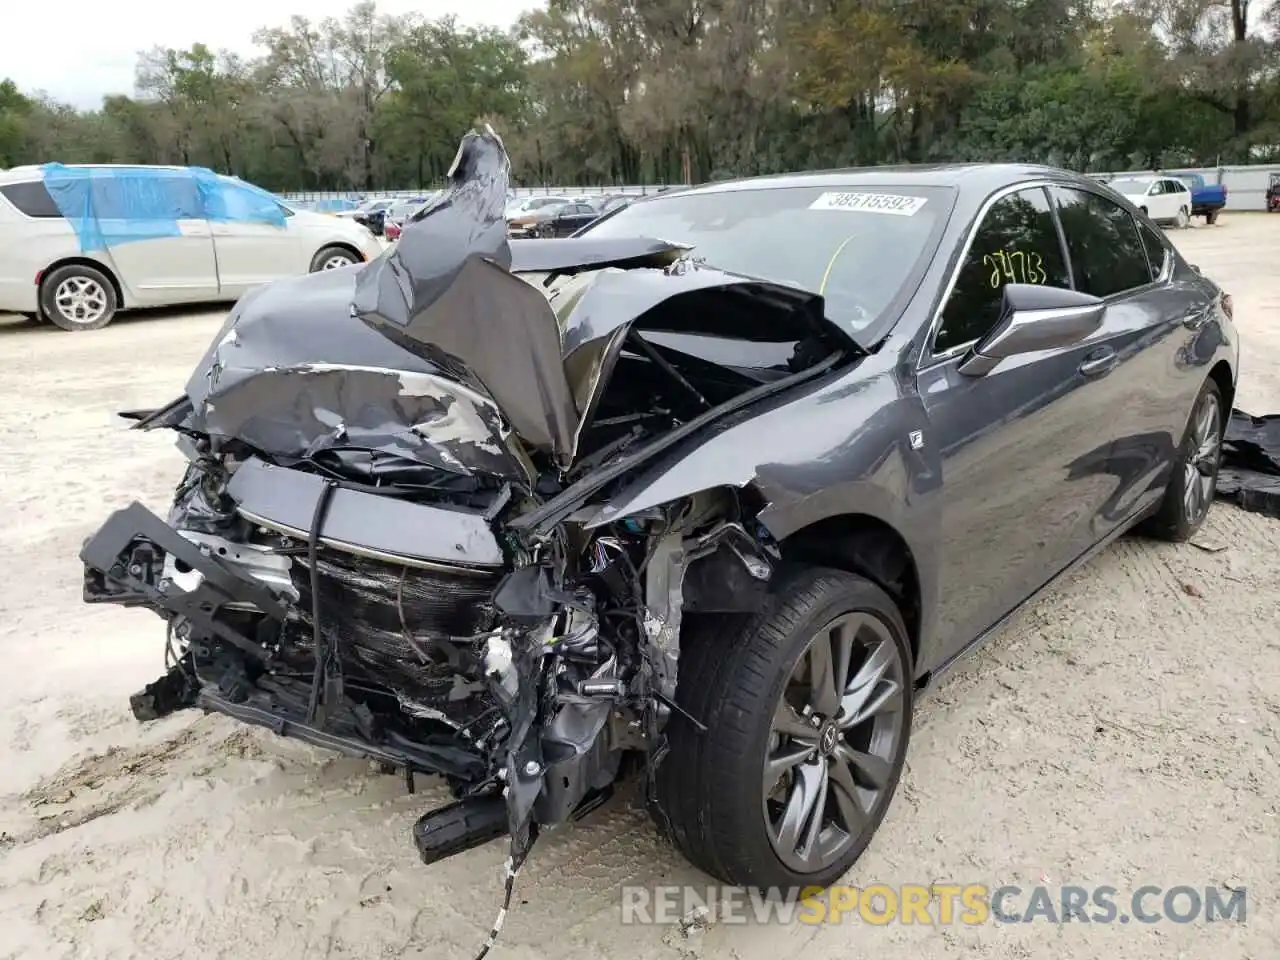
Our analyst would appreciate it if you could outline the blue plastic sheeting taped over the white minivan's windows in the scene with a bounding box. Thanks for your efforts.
[41,164,285,253]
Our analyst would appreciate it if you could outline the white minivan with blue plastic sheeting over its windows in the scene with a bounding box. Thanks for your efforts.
[0,165,383,330]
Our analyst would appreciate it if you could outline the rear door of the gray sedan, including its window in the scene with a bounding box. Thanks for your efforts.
[1051,187,1212,529]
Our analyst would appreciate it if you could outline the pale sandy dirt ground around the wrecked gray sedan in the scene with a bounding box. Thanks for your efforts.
[0,215,1280,960]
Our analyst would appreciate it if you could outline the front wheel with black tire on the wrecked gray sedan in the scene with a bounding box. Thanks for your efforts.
[654,568,913,891]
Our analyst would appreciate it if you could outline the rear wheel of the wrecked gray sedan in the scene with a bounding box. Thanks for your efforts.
[1142,379,1226,543]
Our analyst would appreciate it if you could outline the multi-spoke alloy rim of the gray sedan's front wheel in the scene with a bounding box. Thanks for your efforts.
[763,613,908,873]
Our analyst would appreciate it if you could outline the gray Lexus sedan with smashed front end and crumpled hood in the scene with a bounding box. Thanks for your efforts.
[81,154,1239,910]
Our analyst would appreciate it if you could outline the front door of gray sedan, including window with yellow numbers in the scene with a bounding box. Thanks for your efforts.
[916,186,1131,654]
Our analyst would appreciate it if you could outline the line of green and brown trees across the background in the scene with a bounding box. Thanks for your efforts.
[0,0,1280,191]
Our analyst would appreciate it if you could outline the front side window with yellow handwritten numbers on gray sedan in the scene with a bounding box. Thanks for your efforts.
[933,187,1071,353]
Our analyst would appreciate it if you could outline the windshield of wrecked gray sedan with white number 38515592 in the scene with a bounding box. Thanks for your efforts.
[584,186,954,330]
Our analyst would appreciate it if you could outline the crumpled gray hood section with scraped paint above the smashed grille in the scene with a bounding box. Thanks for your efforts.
[176,264,536,483]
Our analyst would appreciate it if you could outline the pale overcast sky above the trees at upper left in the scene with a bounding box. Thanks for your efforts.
[0,0,529,109]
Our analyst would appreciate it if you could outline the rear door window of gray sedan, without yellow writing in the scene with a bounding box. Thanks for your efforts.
[1053,187,1151,297]
